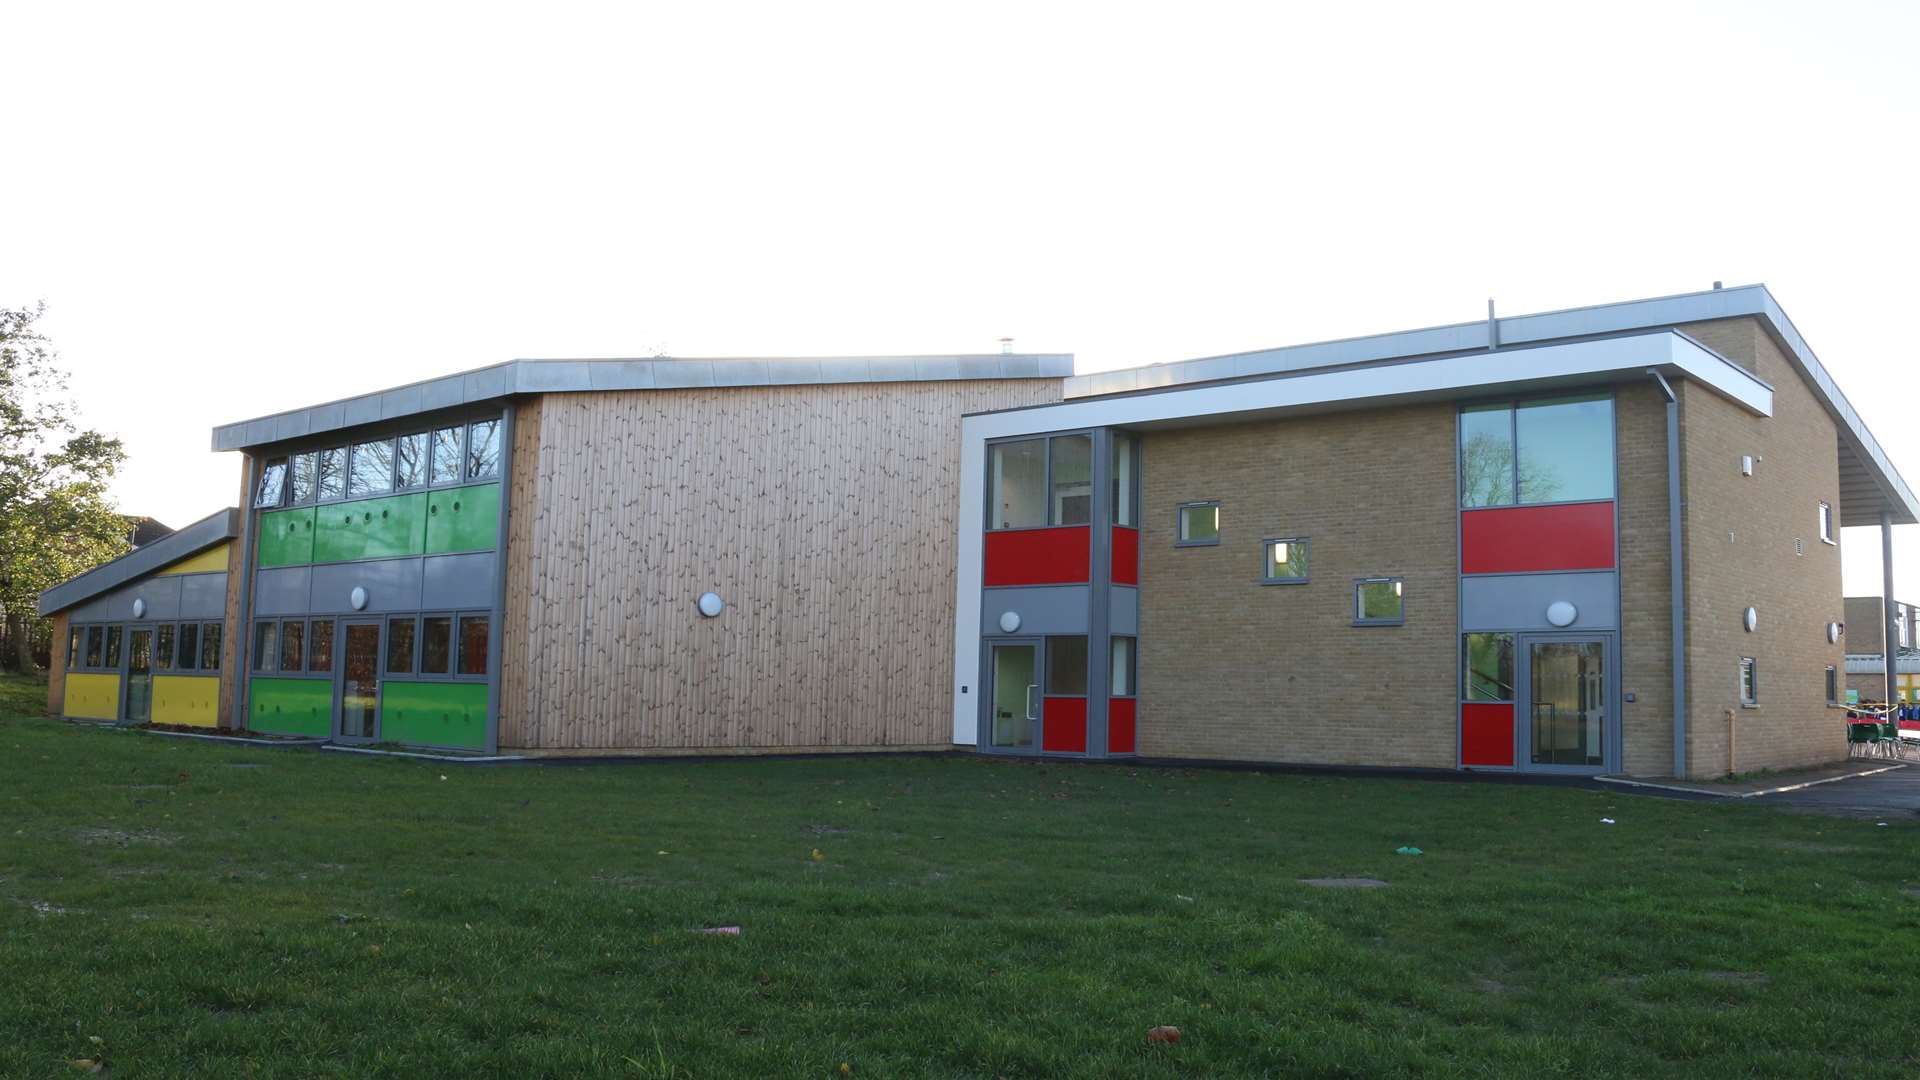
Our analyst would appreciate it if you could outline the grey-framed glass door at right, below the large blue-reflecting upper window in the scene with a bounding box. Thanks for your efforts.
[1519,636,1613,773]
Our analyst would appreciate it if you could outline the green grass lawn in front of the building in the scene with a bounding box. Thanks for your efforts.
[0,668,1920,1080]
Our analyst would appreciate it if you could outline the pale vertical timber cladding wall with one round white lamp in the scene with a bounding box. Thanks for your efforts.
[499,379,1060,751]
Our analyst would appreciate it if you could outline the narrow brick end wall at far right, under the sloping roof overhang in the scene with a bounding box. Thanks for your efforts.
[1680,317,1847,776]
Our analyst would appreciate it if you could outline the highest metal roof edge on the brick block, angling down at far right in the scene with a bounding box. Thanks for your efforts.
[1066,284,1920,525]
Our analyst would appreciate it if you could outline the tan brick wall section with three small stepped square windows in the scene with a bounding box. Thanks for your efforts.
[1139,404,1459,769]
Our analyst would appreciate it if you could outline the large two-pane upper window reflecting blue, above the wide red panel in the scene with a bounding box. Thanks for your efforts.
[1459,394,1613,507]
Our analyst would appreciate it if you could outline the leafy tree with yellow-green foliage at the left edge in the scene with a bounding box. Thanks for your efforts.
[0,304,127,671]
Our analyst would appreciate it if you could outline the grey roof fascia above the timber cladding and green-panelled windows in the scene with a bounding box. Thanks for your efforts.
[213,354,1073,452]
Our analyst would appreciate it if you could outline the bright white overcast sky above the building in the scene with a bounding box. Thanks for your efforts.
[0,0,1920,600]
